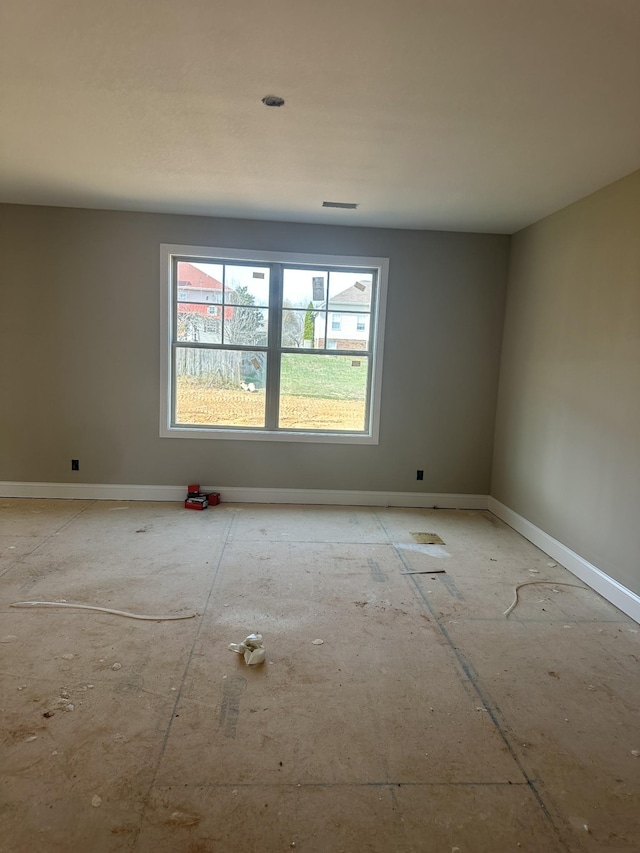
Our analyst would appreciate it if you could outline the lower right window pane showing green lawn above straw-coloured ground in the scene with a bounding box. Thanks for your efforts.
[278,353,368,432]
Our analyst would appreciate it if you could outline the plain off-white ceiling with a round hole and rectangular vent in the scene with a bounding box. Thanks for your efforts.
[0,0,640,233]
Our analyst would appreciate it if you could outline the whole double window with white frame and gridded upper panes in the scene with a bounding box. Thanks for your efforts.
[160,245,388,444]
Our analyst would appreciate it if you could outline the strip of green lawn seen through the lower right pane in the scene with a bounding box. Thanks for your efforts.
[280,353,368,400]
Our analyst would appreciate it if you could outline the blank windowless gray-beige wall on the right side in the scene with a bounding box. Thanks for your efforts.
[491,172,640,593]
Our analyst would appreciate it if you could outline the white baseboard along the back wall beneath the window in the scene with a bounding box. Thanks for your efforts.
[0,481,489,509]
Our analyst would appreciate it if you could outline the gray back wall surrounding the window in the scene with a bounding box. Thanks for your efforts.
[0,205,509,494]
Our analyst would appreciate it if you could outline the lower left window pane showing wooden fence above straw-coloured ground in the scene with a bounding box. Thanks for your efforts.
[175,347,266,427]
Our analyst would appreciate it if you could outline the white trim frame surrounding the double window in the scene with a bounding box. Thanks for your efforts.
[160,243,389,444]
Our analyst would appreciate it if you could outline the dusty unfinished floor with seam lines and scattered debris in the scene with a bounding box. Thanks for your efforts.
[0,500,640,853]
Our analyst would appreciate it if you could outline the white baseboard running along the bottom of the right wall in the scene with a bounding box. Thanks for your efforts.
[488,497,640,623]
